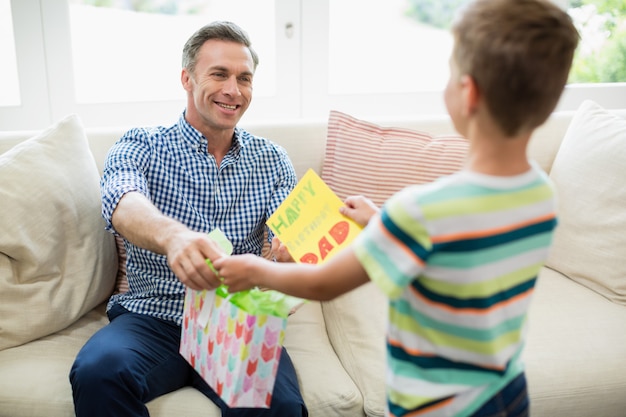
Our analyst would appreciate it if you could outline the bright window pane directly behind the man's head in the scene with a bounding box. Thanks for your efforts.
[69,0,276,103]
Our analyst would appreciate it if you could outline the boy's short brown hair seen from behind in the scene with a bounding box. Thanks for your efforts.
[452,0,579,136]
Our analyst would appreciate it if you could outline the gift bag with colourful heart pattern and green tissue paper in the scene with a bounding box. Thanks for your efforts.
[180,228,303,408]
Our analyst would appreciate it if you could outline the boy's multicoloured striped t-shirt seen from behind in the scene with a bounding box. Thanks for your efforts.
[354,164,556,416]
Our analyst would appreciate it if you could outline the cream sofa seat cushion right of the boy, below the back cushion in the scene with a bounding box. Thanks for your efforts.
[522,268,626,417]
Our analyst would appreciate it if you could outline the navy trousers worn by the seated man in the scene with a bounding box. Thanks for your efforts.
[70,306,308,417]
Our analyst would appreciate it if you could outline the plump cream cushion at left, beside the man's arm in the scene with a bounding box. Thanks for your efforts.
[0,116,117,350]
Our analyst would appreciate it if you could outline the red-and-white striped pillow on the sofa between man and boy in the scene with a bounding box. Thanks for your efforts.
[322,110,469,206]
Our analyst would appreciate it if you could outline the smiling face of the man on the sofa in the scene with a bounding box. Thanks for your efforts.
[182,39,254,130]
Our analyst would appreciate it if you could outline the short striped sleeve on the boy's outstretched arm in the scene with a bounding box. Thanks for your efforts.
[353,190,432,299]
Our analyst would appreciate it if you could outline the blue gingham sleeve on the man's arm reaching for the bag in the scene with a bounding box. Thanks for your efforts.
[100,129,152,234]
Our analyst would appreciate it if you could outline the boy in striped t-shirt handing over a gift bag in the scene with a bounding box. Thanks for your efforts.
[213,0,578,416]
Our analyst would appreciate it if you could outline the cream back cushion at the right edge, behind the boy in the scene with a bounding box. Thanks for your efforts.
[547,101,626,305]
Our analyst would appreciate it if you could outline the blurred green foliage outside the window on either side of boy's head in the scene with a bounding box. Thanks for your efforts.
[407,0,626,83]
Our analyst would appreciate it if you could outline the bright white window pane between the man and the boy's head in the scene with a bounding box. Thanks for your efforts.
[328,0,452,94]
